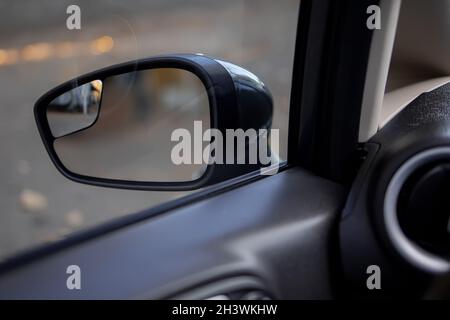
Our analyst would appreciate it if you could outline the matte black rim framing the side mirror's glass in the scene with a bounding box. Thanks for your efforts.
[34,54,242,191]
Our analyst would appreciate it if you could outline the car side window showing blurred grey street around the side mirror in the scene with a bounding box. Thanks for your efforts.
[0,0,299,258]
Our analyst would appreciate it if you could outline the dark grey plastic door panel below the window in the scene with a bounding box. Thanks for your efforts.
[0,168,345,299]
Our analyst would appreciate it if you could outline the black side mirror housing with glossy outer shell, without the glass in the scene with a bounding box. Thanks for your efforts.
[34,54,273,191]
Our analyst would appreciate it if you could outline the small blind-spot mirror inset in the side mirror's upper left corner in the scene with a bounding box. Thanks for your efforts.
[47,80,102,138]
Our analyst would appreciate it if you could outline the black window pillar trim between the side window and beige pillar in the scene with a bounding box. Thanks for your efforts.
[288,0,380,186]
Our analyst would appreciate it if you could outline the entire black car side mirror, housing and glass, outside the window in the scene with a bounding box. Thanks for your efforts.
[34,54,278,190]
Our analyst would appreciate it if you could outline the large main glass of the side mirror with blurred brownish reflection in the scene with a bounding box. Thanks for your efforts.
[47,68,210,182]
